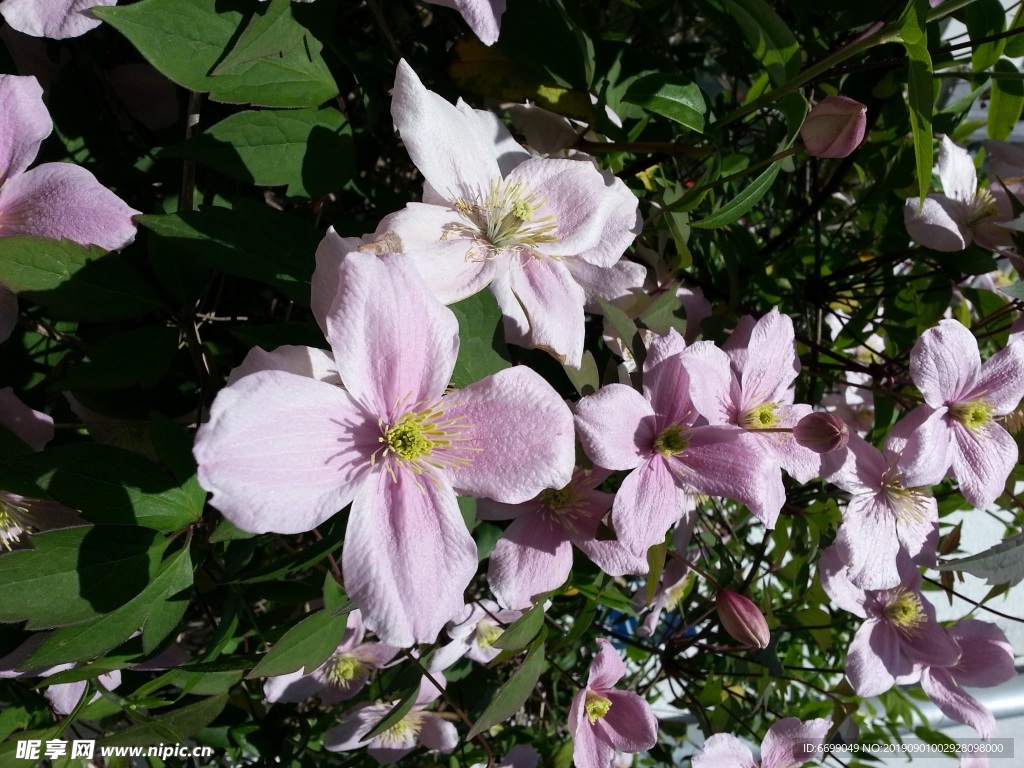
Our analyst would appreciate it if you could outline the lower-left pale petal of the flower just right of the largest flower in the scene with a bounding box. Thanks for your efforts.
[611,456,686,557]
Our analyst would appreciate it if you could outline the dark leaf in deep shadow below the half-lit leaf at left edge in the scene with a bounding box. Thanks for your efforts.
[57,326,178,390]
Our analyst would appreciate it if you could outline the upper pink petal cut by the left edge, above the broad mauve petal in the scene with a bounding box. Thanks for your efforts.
[0,74,53,187]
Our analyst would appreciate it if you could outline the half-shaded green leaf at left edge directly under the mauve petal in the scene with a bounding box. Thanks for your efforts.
[0,234,160,323]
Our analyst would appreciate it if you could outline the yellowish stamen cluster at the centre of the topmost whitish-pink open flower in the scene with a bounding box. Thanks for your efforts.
[441,180,558,261]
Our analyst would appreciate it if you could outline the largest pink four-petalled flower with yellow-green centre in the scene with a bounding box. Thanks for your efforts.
[195,253,573,647]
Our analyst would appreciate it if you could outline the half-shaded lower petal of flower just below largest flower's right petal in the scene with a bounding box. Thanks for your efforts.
[487,514,572,608]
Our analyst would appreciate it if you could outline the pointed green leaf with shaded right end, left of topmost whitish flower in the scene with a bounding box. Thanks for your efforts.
[165,108,355,197]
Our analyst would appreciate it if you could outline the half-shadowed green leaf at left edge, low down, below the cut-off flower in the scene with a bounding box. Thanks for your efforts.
[0,525,165,630]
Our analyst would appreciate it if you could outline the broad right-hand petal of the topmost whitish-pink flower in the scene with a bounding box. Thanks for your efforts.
[508,158,618,266]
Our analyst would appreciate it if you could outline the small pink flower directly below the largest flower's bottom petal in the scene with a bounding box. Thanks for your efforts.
[263,609,398,705]
